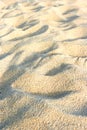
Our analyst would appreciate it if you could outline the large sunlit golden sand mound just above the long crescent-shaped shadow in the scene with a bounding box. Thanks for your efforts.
[13,68,87,94]
